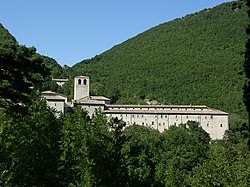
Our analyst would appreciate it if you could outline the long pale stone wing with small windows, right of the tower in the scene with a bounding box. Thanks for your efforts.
[103,105,229,139]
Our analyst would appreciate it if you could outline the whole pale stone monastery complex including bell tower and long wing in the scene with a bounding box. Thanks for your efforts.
[42,76,229,139]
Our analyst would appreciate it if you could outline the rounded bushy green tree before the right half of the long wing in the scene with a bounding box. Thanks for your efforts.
[156,122,210,186]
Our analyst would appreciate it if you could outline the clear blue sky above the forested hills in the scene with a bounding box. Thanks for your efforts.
[0,0,229,66]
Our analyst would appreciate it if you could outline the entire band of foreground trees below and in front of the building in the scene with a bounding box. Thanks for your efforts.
[0,103,250,187]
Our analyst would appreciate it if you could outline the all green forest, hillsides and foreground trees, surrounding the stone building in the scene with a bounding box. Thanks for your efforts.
[0,1,250,187]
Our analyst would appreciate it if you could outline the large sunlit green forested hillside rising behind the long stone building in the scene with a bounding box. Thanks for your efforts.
[71,1,248,121]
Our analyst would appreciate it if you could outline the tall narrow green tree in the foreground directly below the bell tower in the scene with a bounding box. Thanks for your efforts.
[60,108,92,187]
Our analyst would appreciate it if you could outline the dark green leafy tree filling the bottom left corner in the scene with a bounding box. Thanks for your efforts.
[0,97,61,186]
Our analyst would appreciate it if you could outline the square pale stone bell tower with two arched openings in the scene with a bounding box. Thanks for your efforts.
[74,76,89,100]
